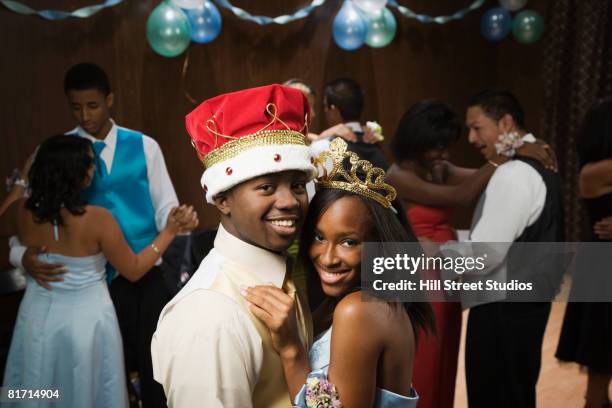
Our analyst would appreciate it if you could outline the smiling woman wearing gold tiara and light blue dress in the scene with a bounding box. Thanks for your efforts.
[243,139,433,408]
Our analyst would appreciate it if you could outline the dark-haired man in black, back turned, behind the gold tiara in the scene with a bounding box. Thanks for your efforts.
[323,78,389,170]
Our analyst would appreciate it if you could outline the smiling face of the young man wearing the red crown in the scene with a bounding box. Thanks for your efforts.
[215,171,308,252]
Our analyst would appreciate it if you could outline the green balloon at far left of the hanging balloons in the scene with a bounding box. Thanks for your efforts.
[147,1,191,57]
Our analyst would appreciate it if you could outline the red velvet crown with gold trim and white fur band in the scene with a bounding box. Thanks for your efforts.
[185,85,315,203]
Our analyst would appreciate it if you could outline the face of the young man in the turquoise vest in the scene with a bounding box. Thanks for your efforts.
[66,88,113,139]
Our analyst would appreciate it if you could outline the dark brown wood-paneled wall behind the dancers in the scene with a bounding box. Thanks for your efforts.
[0,0,552,265]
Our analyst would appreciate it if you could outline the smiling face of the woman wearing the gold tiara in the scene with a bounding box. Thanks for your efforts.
[309,196,371,297]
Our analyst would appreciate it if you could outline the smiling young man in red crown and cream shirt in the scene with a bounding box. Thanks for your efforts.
[151,85,315,408]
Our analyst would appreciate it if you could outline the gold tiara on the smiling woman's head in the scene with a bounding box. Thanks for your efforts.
[314,137,397,208]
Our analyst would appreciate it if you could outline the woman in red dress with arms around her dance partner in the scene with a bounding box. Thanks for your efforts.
[387,100,495,408]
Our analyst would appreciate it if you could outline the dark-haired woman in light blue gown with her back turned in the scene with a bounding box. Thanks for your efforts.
[0,135,188,408]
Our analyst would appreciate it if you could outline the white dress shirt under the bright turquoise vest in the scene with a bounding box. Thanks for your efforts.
[9,119,178,268]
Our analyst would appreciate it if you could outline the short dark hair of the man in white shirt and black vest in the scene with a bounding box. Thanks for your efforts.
[468,89,525,130]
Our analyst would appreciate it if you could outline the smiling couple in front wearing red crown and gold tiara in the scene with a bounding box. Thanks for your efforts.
[151,85,433,408]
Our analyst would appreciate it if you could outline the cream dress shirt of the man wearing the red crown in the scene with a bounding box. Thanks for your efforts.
[151,225,286,408]
